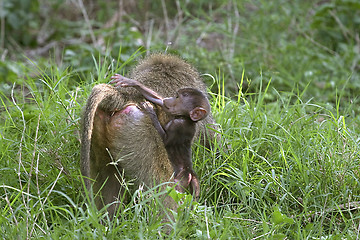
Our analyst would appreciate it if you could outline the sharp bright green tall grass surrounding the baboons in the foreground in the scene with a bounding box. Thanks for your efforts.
[0,56,360,239]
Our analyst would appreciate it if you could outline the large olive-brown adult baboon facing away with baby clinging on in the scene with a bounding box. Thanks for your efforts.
[81,54,216,216]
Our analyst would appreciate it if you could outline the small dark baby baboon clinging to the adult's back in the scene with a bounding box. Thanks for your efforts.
[112,74,210,197]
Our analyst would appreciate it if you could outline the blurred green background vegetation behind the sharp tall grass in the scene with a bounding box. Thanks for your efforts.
[0,0,360,102]
